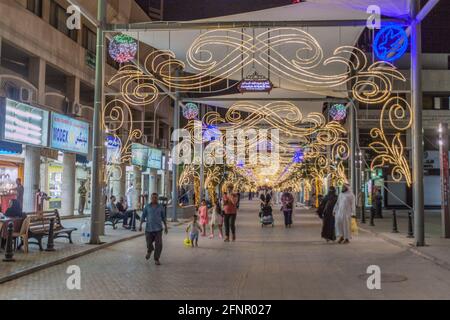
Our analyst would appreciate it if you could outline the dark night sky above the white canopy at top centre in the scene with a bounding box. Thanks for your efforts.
[137,0,292,21]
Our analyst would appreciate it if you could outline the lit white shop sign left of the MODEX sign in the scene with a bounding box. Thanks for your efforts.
[0,98,49,147]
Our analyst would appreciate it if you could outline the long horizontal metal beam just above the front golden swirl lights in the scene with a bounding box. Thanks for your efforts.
[107,19,408,32]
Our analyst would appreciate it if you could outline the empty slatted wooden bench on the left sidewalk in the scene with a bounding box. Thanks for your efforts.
[27,210,77,251]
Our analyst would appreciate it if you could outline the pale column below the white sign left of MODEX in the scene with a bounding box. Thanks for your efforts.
[23,146,41,212]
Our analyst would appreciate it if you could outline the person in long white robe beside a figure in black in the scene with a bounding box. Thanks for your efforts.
[333,185,355,244]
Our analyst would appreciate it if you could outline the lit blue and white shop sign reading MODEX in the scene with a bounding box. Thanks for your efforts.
[50,113,89,154]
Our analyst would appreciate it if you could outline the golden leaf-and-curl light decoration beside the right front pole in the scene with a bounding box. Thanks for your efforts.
[369,97,413,186]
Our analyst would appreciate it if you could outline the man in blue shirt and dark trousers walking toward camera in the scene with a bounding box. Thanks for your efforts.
[139,193,168,266]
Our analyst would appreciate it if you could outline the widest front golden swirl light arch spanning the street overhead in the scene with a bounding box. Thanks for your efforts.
[108,28,406,105]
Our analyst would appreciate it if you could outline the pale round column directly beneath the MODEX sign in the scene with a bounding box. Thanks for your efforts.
[61,152,76,216]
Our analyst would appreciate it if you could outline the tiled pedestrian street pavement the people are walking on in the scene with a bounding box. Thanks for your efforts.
[0,201,450,299]
